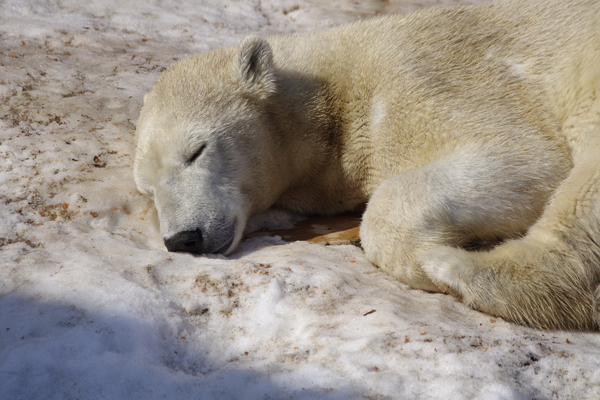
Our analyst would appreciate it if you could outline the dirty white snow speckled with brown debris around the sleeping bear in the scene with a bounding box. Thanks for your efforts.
[0,0,600,399]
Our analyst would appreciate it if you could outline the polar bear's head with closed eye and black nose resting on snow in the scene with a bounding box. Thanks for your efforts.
[134,36,286,253]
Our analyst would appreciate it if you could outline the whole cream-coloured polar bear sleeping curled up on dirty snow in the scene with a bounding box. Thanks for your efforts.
[134,0,600,329]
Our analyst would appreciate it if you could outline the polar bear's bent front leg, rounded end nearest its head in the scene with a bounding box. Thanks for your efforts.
[360,151,560,297]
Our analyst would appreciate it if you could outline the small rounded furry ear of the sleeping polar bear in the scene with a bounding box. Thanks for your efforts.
[236,35,276,99]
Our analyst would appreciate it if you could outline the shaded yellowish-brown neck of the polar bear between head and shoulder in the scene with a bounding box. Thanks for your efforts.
[271,71,371,214]
